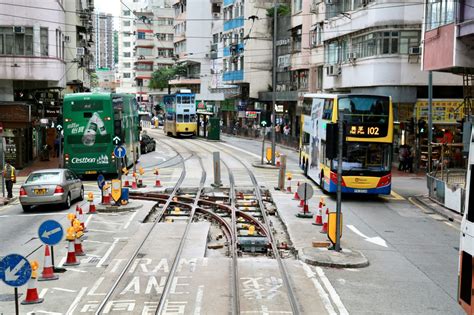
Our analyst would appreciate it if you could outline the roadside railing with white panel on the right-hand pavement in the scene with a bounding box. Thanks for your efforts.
[426,169,466,214]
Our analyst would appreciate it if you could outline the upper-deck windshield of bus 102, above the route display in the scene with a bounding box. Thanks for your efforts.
[338,96,390,123]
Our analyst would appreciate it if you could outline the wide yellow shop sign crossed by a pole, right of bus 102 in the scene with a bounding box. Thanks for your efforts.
[415,100,464,123]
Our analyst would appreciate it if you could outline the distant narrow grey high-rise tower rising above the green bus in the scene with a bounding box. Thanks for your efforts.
[94,13,114,69]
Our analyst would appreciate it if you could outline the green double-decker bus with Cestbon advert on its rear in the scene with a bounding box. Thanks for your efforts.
[63,93,140,175]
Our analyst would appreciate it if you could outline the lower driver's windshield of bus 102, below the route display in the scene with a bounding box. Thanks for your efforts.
[332,142,392,172]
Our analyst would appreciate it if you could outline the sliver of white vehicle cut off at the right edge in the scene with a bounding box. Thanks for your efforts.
[458,128,474,314]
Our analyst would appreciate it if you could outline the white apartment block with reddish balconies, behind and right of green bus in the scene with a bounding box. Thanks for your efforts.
[117,0,174,110]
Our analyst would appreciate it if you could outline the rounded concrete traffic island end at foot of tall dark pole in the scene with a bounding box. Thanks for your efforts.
[298,247,369,268]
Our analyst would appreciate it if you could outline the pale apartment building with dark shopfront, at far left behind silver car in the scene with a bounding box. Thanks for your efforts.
[0,0,94,168]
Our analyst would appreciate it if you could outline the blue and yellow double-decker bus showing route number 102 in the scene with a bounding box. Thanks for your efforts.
[300,94,393,195]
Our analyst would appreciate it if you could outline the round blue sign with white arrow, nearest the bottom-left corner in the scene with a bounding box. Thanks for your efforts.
[0,254,31,287]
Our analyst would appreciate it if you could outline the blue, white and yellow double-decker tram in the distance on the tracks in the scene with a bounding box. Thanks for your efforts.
[163,89,197,136]
